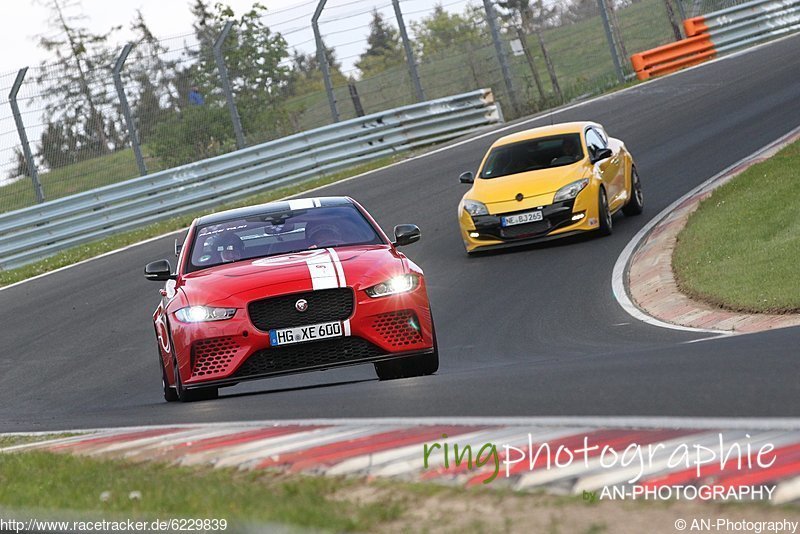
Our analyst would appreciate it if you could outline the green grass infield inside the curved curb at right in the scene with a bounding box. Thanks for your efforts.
[672,138,800,313]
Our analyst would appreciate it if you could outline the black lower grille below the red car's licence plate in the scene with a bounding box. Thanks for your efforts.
[233,337,386,378]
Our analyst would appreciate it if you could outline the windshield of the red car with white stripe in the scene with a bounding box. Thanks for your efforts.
[188,206,383,272]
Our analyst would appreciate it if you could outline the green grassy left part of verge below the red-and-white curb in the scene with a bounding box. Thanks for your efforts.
[0,451,404,532]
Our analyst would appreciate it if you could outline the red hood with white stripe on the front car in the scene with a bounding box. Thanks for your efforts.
[182,245,406,307]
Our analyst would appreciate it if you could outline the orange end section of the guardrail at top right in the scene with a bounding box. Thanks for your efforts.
[631,32,717,80]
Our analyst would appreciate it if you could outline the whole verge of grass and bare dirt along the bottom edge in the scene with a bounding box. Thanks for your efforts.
[0,451,800,533]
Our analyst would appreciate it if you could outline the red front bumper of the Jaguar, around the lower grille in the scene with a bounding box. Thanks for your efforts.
[168,277,434,388]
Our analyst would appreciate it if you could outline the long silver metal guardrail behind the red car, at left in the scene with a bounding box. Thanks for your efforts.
[0,89,503,269]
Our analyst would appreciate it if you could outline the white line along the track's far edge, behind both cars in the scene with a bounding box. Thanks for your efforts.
[0,31,796,291]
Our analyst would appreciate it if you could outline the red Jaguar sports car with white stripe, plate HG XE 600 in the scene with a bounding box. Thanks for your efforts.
[145,197,439,401]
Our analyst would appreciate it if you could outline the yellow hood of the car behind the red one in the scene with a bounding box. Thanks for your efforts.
[466,161,591,205]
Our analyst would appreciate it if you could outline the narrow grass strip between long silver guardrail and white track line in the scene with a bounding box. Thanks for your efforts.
[0,155,400,287]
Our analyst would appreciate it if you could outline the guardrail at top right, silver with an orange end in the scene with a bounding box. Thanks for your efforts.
[631,0,800,80]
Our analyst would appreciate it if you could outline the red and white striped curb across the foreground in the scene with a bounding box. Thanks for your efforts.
[0,417,800,504]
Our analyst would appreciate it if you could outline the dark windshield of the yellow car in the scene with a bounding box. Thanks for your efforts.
[481,133,583,178]
